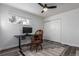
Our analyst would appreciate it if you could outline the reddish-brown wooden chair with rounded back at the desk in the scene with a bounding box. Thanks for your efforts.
[30,30,43,52]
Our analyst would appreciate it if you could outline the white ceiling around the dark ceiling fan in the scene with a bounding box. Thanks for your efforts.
[6,3,79,17]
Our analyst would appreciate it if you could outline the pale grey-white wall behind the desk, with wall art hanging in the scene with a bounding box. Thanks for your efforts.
[0,4,43,50]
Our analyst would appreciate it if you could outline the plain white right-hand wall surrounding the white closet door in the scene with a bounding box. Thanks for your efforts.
[44,9,79,47]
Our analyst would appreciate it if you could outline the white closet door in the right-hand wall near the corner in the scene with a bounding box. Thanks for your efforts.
[44,20,61,42]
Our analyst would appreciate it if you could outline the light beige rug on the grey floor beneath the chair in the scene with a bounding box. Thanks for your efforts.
[24,47,65,56]
